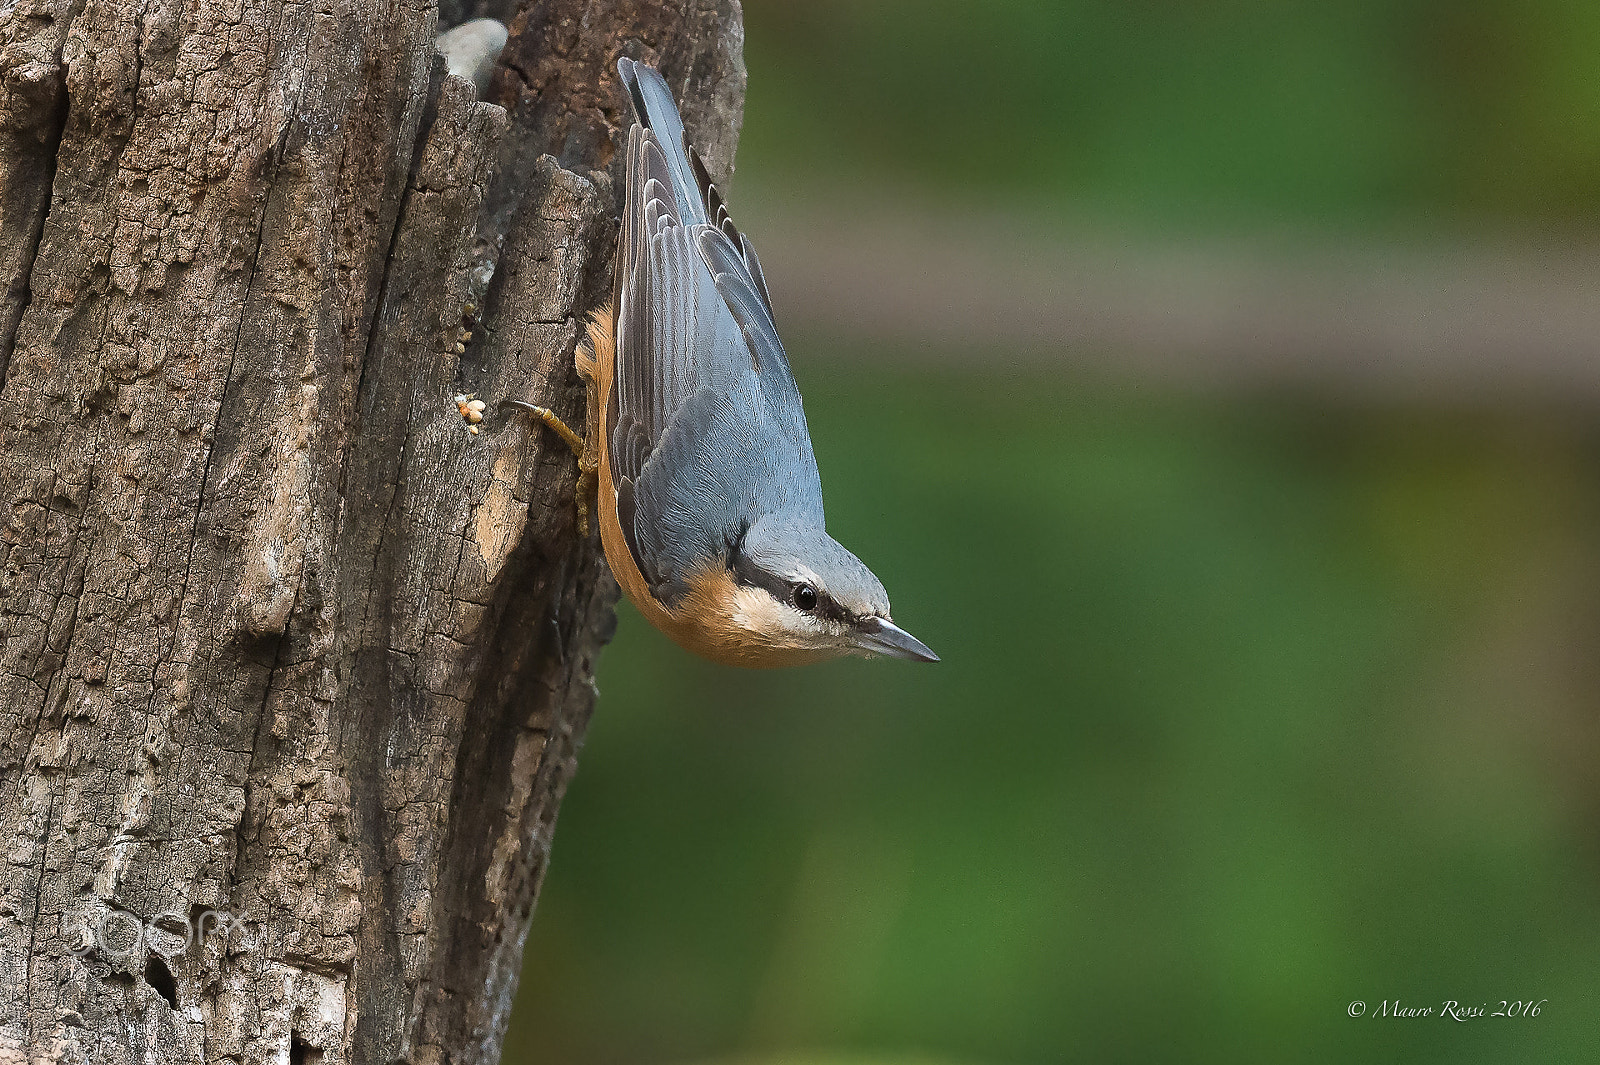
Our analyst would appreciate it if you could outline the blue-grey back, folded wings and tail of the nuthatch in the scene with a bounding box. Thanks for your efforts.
[606,61,822,603]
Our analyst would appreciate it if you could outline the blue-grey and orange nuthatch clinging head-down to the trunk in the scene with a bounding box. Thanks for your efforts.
[510,59,939,667]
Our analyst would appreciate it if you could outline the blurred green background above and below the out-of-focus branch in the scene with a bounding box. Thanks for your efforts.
[506,0,1600,1065]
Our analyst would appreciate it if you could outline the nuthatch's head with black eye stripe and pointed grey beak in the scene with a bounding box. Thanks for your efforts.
[688,518,939,665]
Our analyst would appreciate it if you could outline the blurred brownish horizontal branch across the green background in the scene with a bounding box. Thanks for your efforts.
[736,189,1600,403]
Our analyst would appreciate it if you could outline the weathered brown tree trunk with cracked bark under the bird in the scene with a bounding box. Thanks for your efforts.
[0,0,744,1065]
